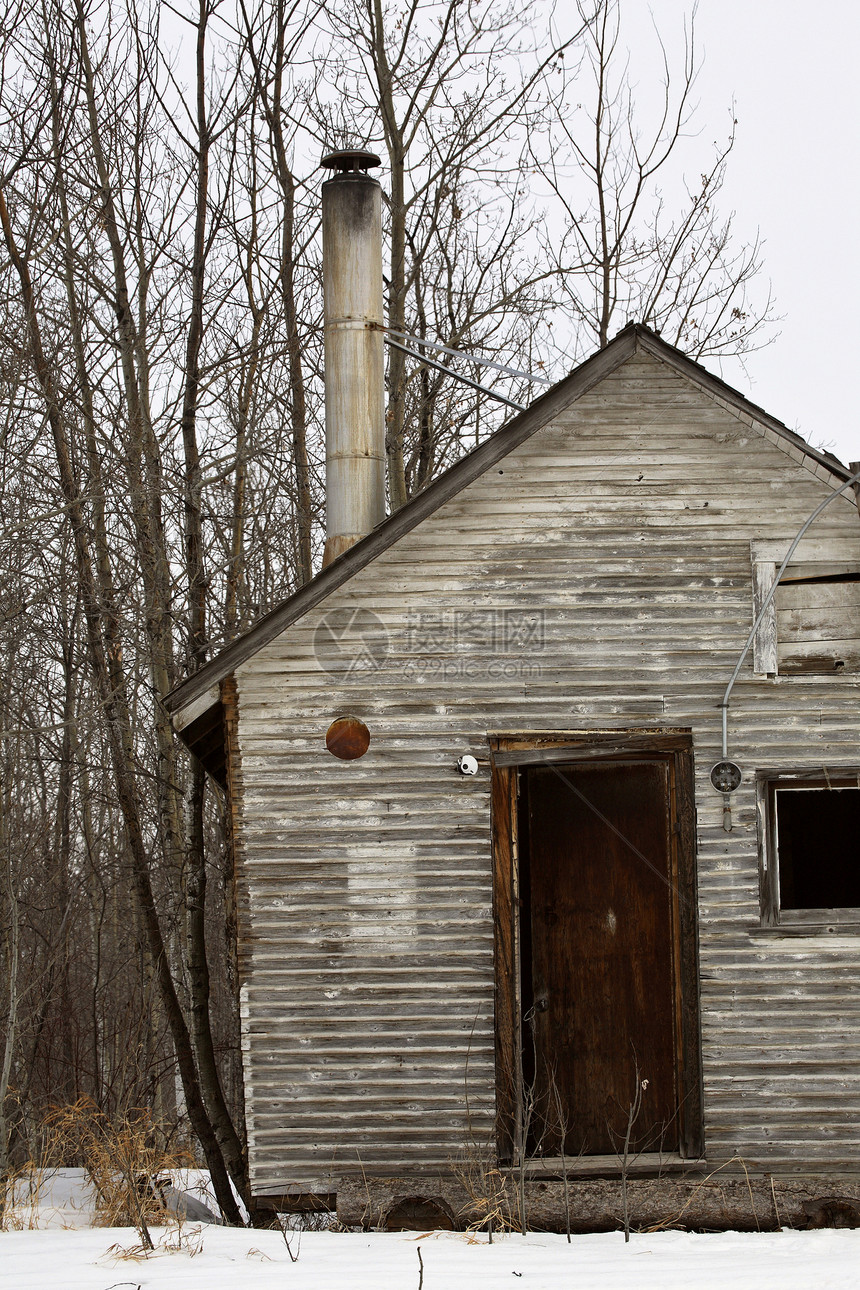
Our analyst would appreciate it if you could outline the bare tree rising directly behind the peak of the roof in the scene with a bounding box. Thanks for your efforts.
[533,0,771,357]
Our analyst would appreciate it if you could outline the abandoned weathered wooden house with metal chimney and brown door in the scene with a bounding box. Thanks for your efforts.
[163,150,860,1226]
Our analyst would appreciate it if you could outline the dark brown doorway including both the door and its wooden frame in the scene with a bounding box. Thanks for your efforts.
[494,735,701,1158]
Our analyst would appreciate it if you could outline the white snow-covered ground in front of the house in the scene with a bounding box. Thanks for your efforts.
[0,1224,860,1290]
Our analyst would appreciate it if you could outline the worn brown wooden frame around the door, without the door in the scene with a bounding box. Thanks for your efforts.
[489,726,704,1164]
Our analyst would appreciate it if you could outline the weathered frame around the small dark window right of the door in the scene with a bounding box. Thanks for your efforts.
[756,766,860,933]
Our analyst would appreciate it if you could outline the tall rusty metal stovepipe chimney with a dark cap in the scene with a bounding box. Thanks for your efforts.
[321,150,386,568]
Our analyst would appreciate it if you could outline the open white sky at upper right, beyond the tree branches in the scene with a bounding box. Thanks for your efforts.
[623,0,860,463]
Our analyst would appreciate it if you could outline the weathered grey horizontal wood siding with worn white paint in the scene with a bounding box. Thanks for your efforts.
[233,356,860,1193]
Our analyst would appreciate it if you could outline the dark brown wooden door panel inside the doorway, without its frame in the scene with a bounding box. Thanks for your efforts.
[520,757,679,1156]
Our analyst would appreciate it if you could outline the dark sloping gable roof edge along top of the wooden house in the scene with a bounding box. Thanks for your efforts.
[165,323,851,729]
